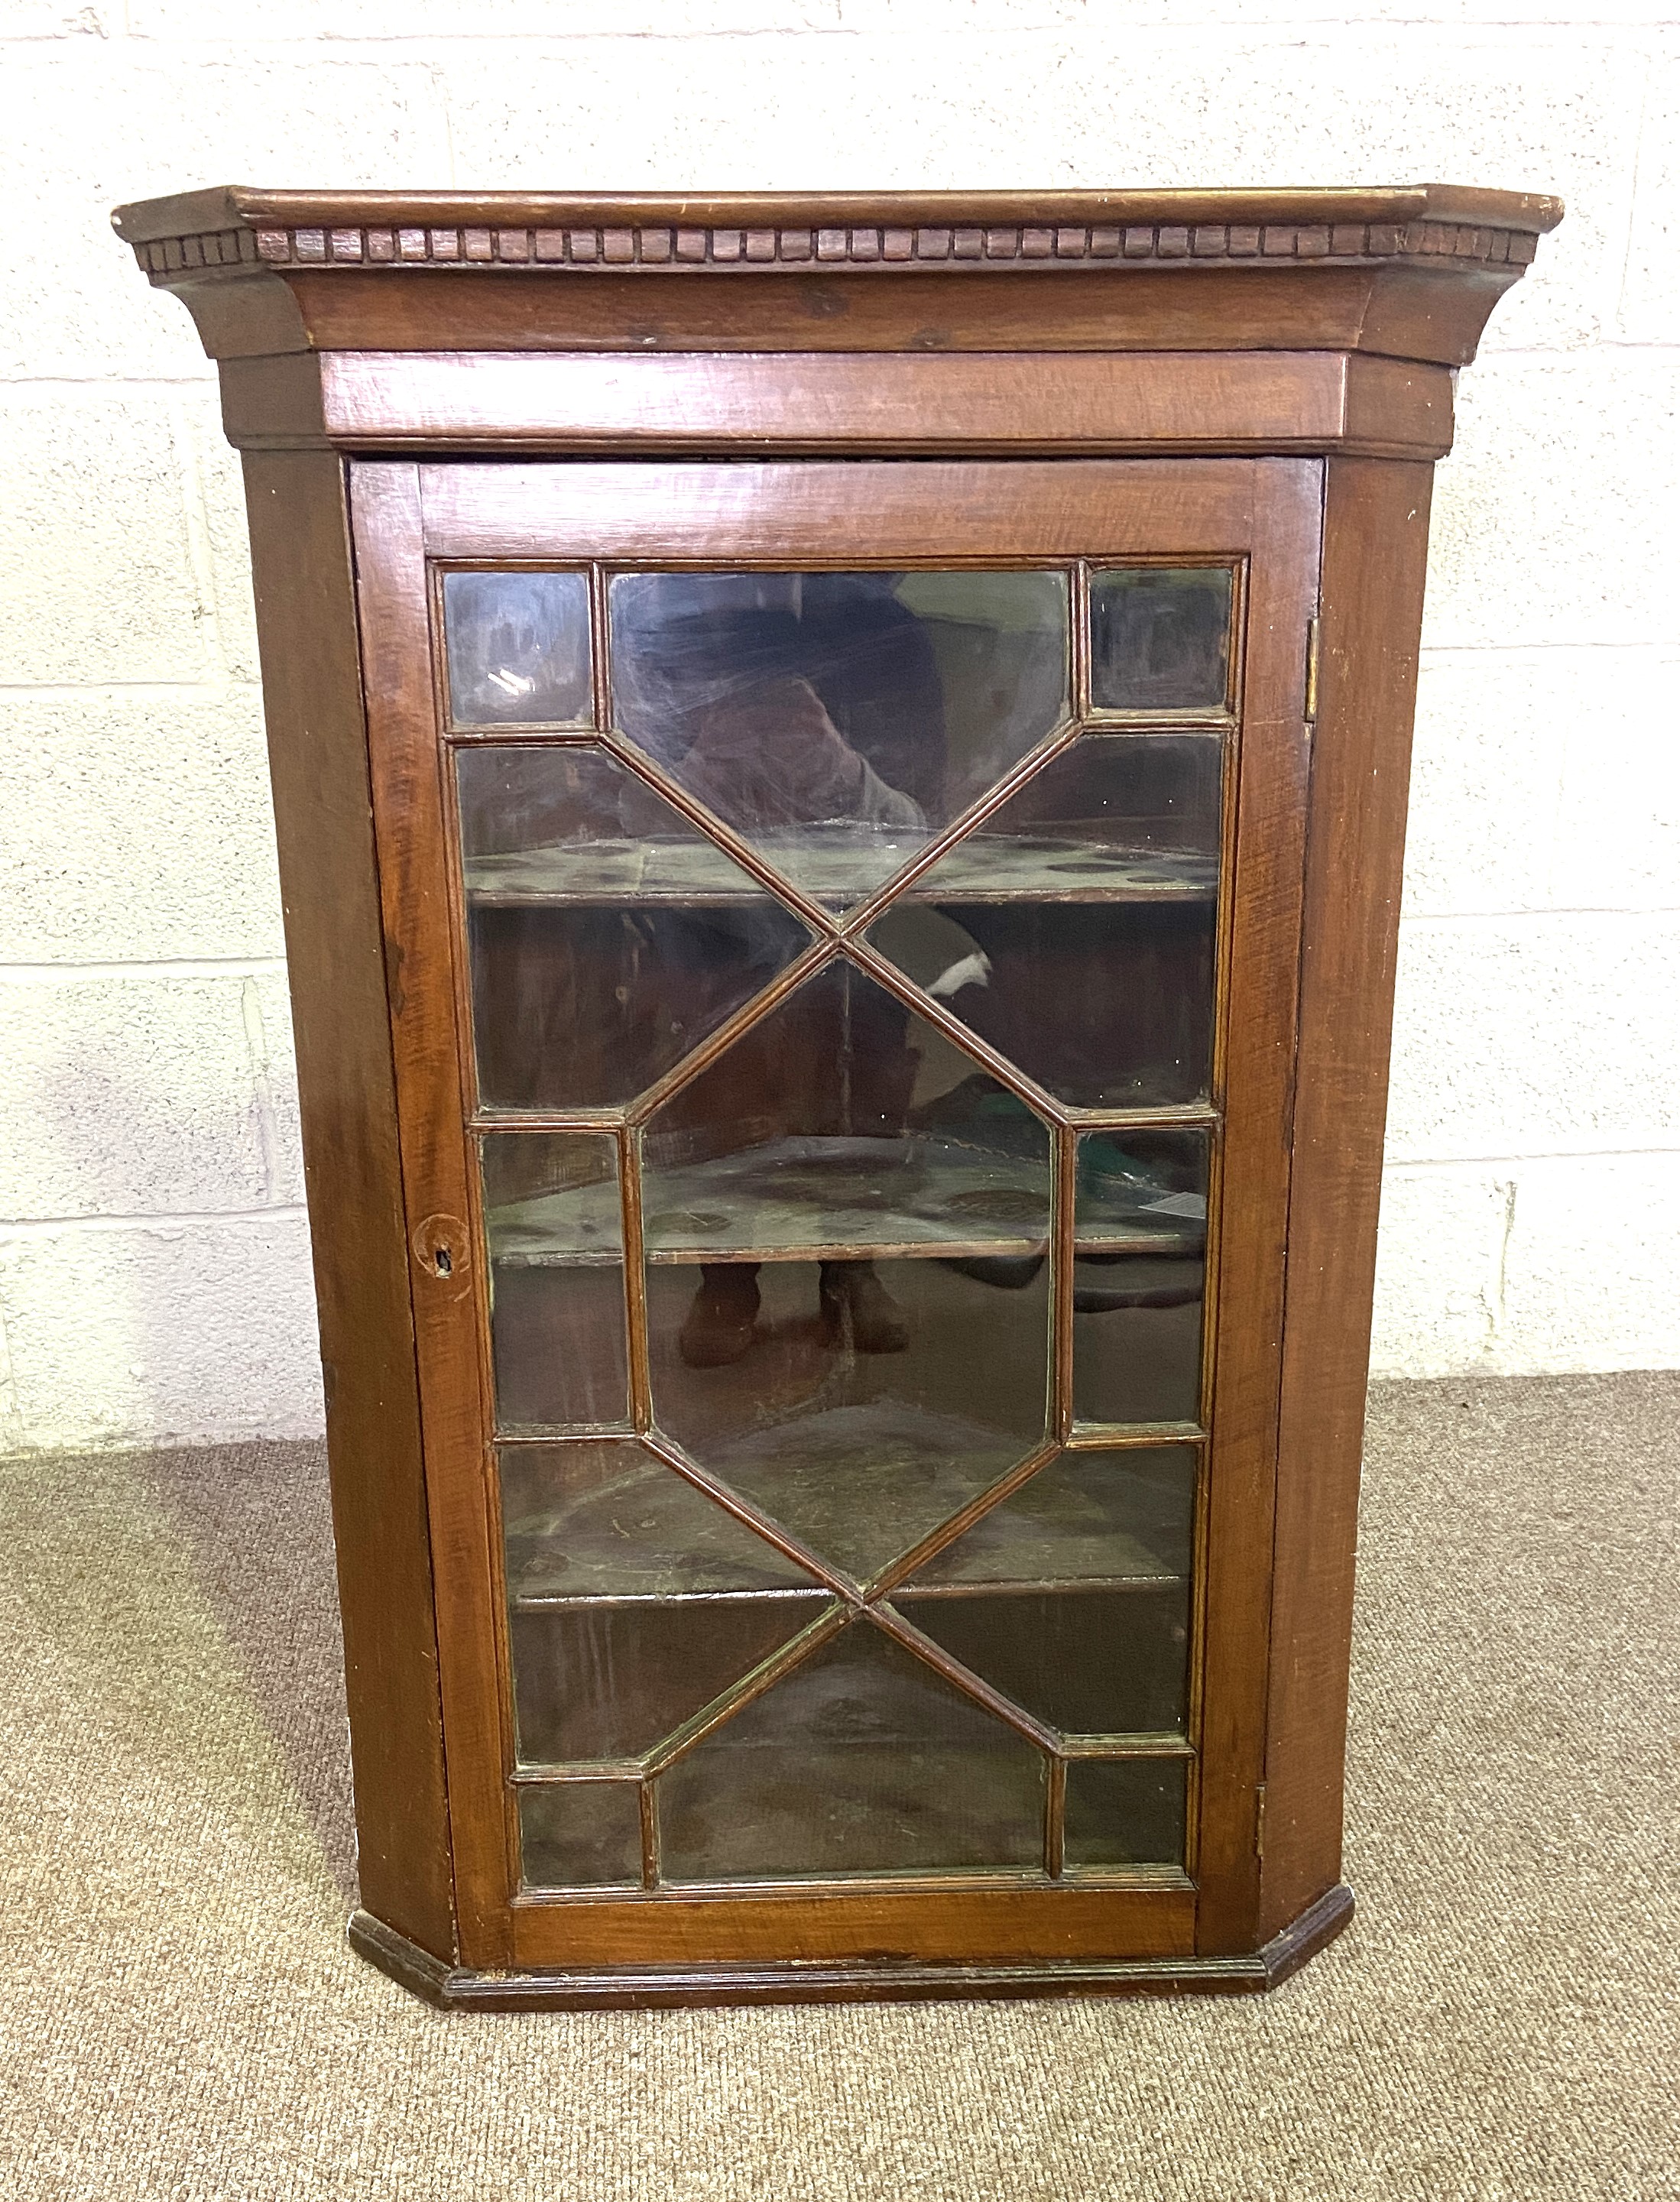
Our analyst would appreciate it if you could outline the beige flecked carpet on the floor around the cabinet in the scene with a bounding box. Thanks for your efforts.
[0,1374,1680,2202]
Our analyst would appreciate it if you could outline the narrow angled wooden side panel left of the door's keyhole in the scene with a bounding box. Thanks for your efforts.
[245,453,456,1957]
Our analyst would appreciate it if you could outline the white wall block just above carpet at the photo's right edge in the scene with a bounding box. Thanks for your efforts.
[1493,1152,1680,1377]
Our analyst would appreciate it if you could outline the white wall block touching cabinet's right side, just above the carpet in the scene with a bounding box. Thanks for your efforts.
[1372,1165,1510,1377]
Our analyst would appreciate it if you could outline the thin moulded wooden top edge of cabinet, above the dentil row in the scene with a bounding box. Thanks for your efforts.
[112,183,1563,245]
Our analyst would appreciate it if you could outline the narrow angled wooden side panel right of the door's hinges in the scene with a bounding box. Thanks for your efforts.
[1260,458,1431,1935]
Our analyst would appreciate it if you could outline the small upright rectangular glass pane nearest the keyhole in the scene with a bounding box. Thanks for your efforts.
[480,1132,630,1429]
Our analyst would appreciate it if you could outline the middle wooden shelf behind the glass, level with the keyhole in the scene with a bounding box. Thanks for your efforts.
[487,1132,1205,1268]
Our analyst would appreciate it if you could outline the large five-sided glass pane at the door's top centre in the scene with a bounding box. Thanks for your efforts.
[610,572,1068,907]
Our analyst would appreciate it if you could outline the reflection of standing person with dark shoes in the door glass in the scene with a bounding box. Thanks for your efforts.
[618,575,945,1367]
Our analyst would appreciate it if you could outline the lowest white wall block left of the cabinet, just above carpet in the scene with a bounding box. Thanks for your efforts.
[0,1211,322,1447]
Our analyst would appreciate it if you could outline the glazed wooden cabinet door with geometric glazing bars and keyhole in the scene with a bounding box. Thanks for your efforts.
[352,460,1321,1970]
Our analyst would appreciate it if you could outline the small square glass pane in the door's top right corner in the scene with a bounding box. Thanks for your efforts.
[1090,566,1231,712]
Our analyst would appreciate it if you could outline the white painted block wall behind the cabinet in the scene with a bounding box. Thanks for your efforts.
[0,0,1680,1449]
